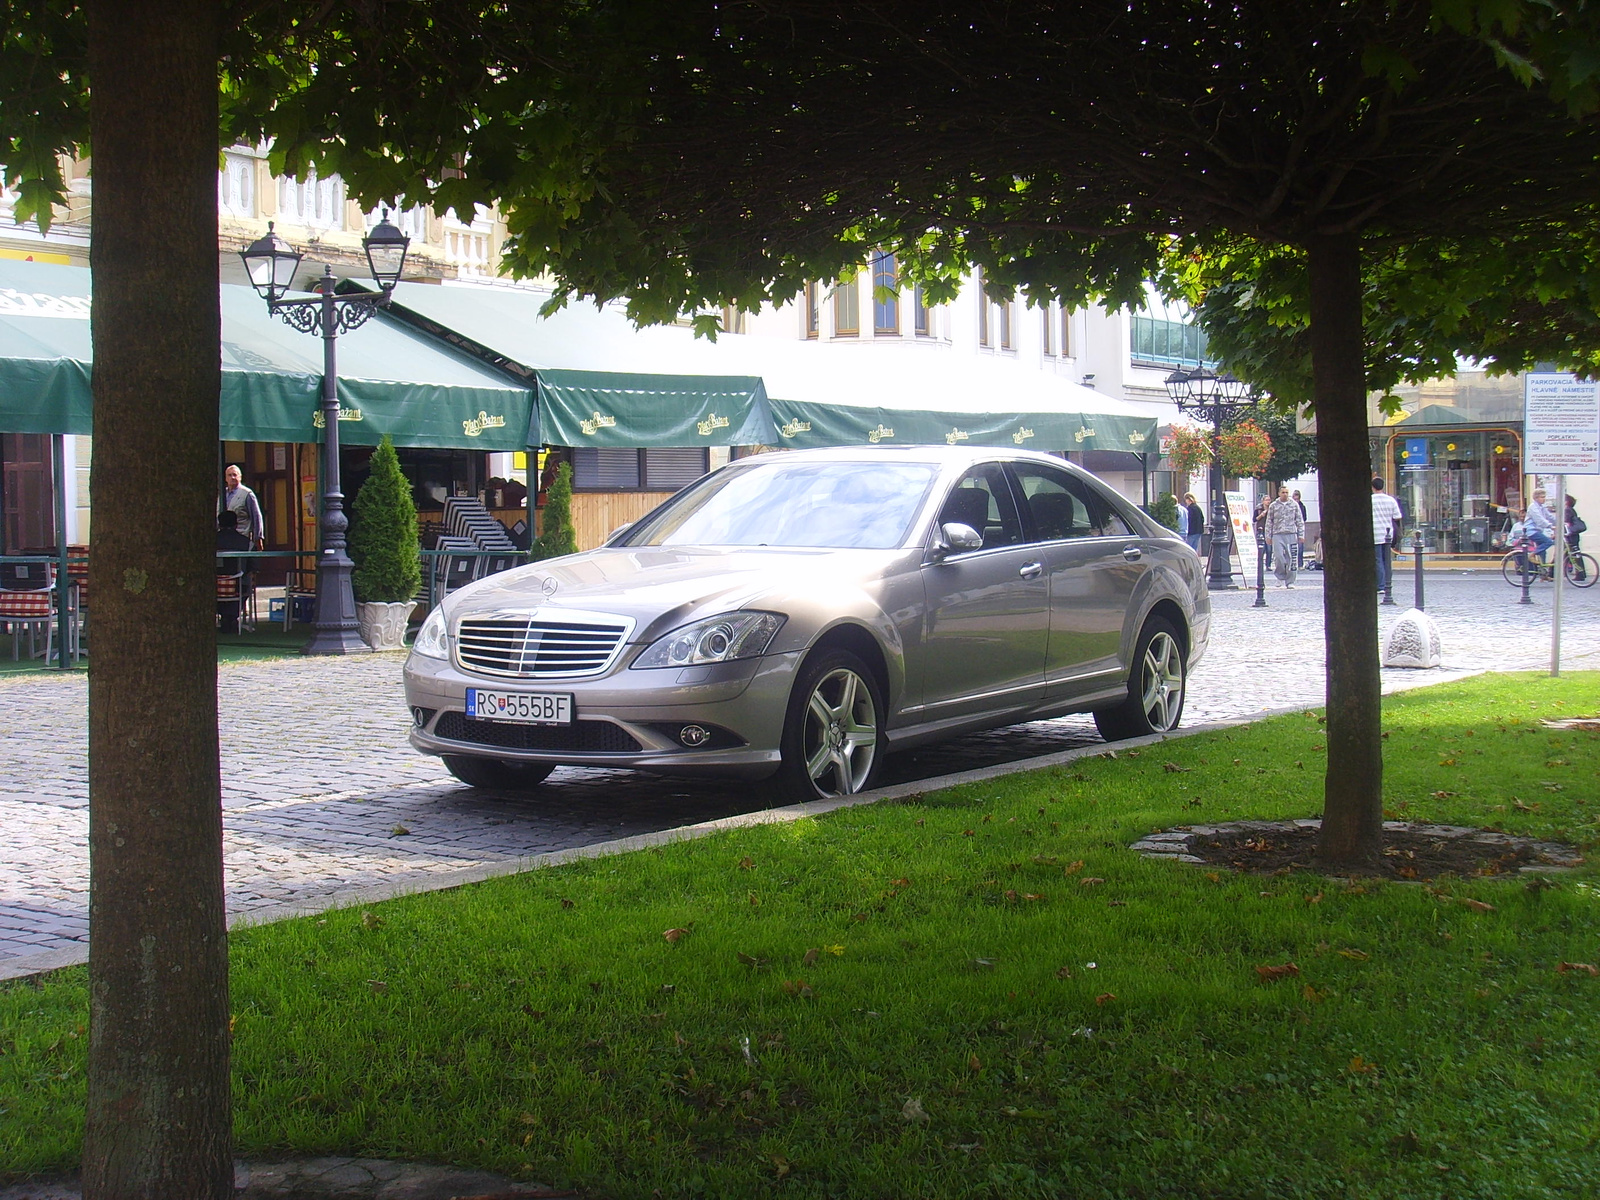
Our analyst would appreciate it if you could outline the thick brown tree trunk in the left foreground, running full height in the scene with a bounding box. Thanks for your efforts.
[83,0,234,1200]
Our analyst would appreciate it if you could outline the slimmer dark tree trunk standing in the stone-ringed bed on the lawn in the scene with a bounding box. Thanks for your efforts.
[1306,234,1384,869]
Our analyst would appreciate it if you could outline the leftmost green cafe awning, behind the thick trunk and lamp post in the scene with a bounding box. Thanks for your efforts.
[0,259,533,451]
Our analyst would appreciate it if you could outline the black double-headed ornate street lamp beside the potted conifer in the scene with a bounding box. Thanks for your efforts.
[238,213,411,654]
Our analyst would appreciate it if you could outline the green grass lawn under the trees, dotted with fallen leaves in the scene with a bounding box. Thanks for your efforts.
[0,674,1600,1200]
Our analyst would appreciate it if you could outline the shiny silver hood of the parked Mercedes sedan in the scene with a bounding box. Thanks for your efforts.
[450,546,904,640]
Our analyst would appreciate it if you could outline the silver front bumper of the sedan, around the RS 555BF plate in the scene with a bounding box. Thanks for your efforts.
[396,651,805,779]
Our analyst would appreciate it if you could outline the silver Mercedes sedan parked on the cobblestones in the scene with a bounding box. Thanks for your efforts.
[405,446,1211,800]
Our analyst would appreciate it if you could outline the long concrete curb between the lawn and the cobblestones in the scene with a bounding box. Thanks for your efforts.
[0,667,1485,981]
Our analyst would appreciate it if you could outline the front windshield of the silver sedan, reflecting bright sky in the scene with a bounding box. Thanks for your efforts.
[619,459,938,550]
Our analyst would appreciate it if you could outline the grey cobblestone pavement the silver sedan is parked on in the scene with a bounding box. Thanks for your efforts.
[0,571,1600,978]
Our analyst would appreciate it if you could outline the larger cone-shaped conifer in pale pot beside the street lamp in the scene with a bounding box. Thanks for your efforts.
[350,434,422,650]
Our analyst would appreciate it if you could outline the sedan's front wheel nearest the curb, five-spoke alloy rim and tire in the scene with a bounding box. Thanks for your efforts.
[778,650,888,802]
